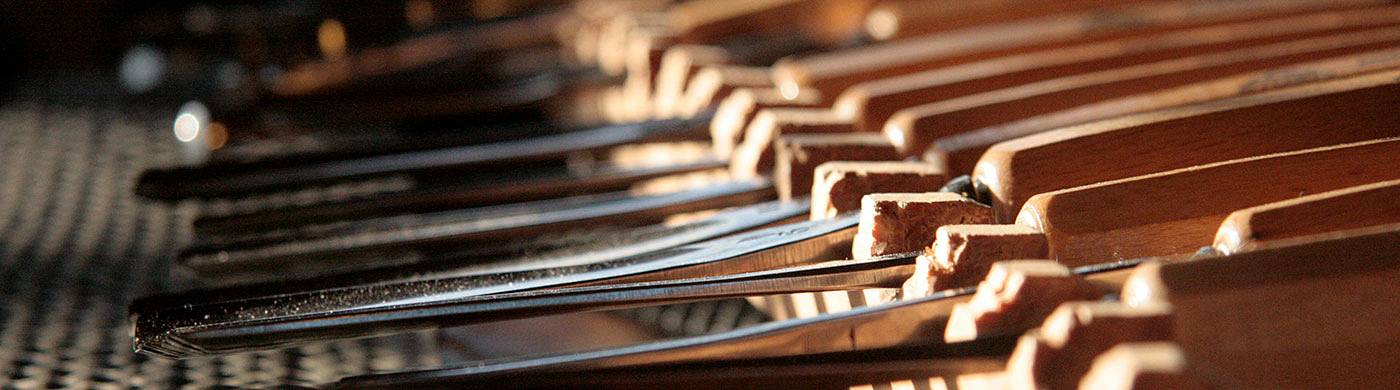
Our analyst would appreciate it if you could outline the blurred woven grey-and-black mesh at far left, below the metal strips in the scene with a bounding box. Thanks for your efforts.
[0,94,764,389]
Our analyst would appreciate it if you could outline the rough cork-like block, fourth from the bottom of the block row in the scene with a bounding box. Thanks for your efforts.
[904,225,1050,296]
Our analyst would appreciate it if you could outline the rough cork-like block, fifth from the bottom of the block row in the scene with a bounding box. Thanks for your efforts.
[851,193,991,259]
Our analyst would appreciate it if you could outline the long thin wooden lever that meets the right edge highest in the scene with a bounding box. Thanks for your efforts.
[833,7,1400,131]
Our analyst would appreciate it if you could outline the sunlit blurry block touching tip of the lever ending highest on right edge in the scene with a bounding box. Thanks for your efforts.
[710,88,818,158]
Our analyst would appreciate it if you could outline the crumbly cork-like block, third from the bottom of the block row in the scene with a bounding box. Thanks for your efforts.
[944,260,1106,342]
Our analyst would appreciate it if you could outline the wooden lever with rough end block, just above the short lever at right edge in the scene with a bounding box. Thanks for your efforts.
[906,138,1400,294]
